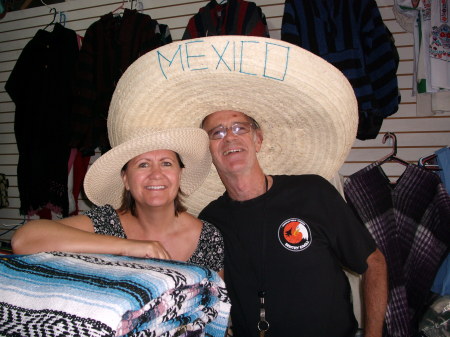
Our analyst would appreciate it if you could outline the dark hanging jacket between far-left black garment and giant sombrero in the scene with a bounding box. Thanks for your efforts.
[71,9,171,156]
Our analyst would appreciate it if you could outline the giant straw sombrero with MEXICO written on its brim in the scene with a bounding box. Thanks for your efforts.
[108,35,358,215]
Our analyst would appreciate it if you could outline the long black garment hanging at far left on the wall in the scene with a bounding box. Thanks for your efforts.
[5,24,79,216]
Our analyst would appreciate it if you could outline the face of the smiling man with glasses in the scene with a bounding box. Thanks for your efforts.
[203,110,262,174]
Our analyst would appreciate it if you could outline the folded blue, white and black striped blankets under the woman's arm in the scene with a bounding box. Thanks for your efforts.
[0,252,230,337]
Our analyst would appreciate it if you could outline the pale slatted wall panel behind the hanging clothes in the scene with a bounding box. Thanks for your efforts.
[0,0,450,244]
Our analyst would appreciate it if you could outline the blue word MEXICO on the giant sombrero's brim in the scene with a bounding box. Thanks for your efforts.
[157,40,290,81]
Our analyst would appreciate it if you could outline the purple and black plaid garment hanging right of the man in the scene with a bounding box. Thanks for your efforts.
[344,163,450,337]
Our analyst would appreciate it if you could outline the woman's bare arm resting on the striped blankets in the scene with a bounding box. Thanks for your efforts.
[11,215,170,259]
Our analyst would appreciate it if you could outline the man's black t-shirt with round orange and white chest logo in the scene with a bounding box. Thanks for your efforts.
[199,175,376,337]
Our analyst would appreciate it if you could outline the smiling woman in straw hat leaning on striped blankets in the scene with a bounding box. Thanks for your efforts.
[11,128,223,277]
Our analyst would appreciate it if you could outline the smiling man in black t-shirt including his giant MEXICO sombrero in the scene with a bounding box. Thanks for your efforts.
[104,36,387,337]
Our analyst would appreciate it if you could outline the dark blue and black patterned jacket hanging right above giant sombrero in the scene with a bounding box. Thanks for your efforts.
[281,0,400,140]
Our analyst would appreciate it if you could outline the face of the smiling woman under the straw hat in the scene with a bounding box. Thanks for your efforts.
[122,150,181,207]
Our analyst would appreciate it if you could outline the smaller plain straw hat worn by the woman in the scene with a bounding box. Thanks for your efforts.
[84,127,211,209]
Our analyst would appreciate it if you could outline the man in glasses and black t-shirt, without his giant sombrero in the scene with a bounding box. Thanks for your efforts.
[199,111,387,337]
